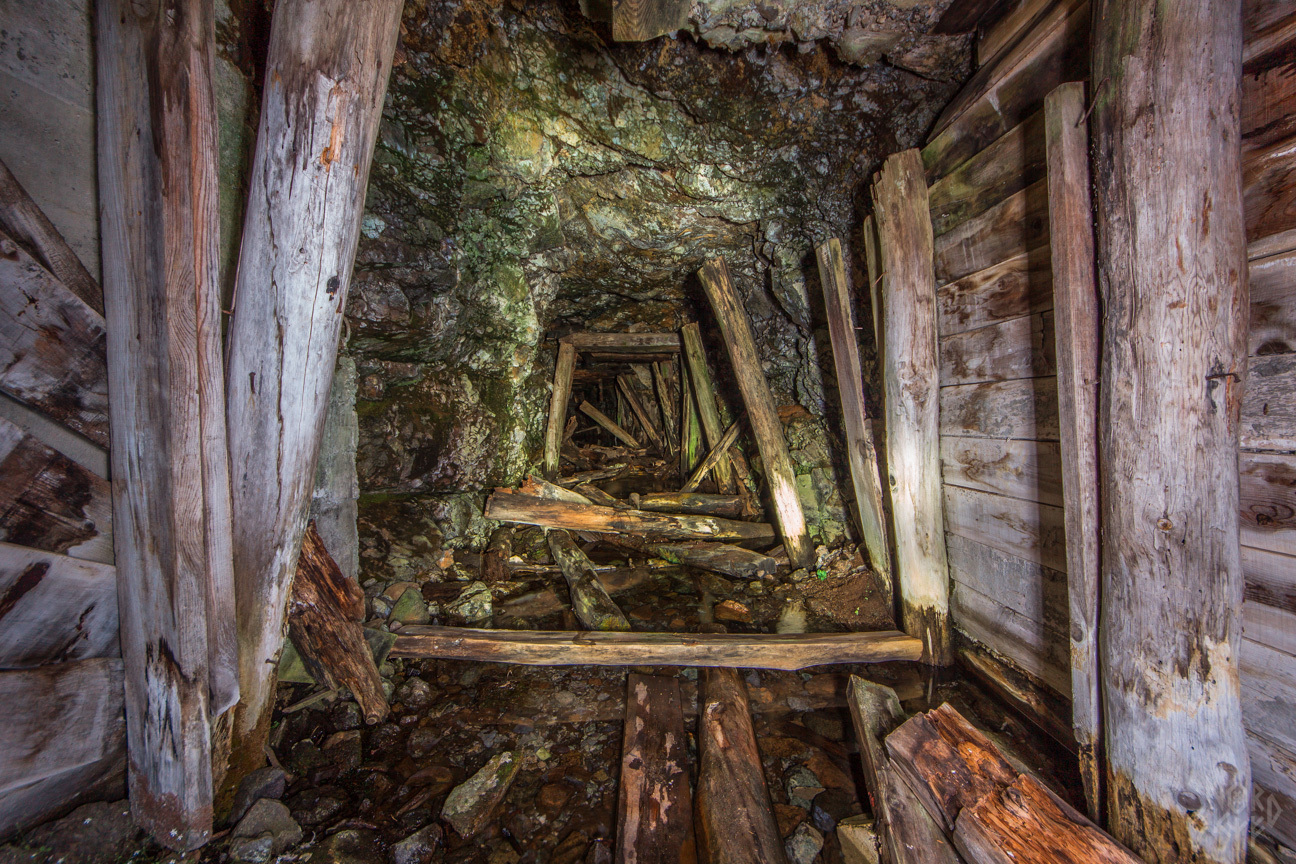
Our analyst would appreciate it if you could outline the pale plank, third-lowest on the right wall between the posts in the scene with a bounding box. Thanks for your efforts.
[945,486,1067,573]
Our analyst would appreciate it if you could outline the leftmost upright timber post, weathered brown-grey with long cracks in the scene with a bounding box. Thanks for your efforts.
[95,0,238,850]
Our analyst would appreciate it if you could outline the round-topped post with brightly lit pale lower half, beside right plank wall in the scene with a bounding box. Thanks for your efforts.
[874,150,950,666]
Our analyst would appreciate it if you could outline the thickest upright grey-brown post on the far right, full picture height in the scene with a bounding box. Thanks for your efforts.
[1093,0,1251,864]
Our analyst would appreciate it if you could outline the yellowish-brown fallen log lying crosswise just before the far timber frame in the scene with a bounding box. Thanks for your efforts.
[486,492,774,543]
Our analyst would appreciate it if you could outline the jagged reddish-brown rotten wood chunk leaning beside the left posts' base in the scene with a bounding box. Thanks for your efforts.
[288,522,389,725]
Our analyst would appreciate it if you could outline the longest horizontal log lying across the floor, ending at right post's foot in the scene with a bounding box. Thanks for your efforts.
[391,626,923,670]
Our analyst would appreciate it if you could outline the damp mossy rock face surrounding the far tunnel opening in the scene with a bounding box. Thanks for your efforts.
[346,0,968,507]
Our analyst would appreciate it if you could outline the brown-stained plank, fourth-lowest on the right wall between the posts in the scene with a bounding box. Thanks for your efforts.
[941,435,1063,506]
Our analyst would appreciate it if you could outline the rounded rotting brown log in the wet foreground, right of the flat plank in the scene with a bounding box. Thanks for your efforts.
[695,668,788,864]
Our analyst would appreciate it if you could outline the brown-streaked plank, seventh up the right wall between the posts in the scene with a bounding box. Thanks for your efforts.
[936,246,1052,337]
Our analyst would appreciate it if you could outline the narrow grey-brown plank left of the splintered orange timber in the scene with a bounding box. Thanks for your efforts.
[846,675,959,864]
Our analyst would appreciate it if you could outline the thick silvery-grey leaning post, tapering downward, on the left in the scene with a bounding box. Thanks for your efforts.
[228,0,400,782]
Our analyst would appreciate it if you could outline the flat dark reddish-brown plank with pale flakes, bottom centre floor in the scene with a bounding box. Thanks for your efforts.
[616,674,697,864]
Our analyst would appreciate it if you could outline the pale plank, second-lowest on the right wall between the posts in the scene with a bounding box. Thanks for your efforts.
[945,534,1070,632]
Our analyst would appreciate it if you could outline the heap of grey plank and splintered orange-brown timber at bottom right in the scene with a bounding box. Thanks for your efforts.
[849,677,1139,864]
